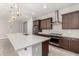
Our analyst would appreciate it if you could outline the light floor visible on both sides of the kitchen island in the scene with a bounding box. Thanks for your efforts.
[0,39,79,56]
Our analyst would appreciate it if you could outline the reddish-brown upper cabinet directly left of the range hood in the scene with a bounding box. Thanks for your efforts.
[41,18,52,29]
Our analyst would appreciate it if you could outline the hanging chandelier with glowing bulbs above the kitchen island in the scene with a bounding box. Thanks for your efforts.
[8,4,20,23]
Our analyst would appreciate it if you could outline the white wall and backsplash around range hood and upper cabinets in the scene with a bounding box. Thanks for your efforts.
[34,4,79,36]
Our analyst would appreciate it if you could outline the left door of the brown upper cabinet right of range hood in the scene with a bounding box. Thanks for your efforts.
[62,14,73,29]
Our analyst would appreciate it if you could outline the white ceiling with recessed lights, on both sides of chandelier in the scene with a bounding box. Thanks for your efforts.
[0,3,75,19]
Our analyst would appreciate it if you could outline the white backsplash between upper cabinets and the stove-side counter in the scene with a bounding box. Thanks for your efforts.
[41,24,79,36]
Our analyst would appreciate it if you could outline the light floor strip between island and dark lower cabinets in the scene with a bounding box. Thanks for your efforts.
[49,45,79,56]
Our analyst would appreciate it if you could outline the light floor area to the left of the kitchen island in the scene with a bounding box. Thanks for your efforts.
[0,39,18,56]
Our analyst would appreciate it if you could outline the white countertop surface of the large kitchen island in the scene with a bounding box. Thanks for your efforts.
[7,33,49,50]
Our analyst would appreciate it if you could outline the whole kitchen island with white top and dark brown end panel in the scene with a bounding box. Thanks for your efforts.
[7,33,50,56]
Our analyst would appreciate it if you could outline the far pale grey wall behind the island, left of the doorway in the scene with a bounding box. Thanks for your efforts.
[8,21,23,33]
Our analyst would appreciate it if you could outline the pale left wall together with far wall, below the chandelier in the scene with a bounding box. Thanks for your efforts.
[0,19,23,39]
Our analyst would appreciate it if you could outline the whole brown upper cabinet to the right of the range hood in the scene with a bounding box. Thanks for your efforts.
[62,11,79,29]
